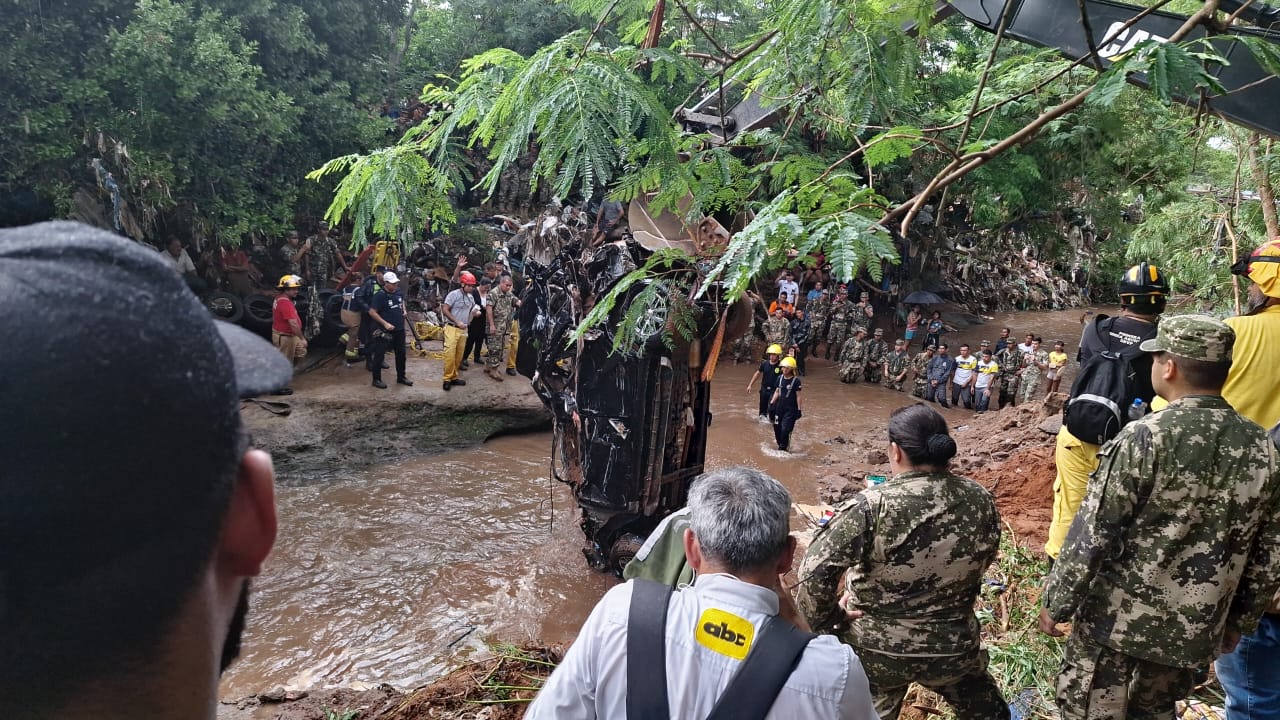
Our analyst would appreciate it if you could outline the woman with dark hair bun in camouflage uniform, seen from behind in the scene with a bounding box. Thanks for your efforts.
[796,404,1009,720]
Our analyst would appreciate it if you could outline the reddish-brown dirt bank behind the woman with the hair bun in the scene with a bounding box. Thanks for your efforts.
[818,395,1064,548]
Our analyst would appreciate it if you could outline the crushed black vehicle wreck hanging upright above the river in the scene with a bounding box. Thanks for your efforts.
[508,201,753,571]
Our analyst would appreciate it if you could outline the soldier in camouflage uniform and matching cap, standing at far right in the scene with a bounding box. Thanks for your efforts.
[1039,315,1280,720]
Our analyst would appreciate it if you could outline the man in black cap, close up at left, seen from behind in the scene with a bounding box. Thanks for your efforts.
[0,223,291,719]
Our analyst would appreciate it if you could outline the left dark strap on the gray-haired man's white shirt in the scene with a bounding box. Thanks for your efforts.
[627,578,671,720]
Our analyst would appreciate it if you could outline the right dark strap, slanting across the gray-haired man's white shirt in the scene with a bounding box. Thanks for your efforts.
[706,615,817,720]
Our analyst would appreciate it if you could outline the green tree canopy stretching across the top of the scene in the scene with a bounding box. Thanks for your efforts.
[10,0,1280,311]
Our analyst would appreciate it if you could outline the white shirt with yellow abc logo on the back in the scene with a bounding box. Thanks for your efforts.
[525,575,877,720]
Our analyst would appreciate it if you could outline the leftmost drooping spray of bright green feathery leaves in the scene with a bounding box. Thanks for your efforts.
[307,145,457,250]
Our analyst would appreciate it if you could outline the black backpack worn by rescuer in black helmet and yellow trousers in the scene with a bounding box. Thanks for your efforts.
[1062,318,1142,445]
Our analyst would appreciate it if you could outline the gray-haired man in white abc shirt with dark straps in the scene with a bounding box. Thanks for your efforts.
[525,466,876,720]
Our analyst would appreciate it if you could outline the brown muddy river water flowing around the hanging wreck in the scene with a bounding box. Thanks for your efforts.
[220,304,1100,698]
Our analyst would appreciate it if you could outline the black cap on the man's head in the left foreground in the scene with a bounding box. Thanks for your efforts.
[0,222,292,530]
